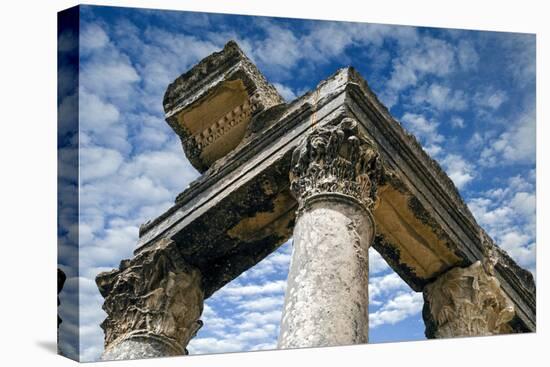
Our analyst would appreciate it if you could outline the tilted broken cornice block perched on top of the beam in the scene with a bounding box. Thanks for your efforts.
[163,41,284,172]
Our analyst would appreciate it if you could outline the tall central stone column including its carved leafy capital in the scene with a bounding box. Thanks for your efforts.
[279,118,380,348]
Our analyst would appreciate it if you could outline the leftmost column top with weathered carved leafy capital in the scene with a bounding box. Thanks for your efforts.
[96,239,204,360]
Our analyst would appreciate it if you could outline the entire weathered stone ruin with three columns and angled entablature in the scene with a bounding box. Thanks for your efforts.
[96,41,536,360]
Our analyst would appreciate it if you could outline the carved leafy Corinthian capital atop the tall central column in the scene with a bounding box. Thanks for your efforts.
[290,118,381,208]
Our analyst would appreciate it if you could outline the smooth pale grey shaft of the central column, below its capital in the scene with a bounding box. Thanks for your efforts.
[278,194,374,348]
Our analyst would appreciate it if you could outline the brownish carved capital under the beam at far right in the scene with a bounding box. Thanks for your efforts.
[422,235,515,339]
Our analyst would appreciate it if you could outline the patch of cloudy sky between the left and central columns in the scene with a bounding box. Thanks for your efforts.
[188,241,291,354]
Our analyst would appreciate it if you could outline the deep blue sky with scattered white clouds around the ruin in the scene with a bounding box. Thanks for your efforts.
[59,6,535,360]
